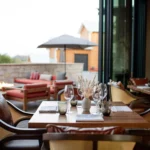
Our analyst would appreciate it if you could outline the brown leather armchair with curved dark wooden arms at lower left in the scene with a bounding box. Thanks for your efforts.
[0,96,46,150]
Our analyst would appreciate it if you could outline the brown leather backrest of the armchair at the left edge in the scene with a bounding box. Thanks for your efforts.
[0,97,13,125]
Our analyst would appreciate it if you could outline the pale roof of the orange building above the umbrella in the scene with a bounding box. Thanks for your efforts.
[79,21,99,33]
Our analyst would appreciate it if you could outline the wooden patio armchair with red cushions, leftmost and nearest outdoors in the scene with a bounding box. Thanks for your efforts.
[4,83,50,110]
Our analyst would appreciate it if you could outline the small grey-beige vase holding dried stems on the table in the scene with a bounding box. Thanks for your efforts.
[82,98,91,114]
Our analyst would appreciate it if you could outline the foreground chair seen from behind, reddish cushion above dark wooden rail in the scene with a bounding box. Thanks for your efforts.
[42,125,149,150]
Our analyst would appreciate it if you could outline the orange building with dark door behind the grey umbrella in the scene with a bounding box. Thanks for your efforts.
[56,22,98,71]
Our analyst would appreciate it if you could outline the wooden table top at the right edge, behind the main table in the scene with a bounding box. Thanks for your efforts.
[127,85,150,95]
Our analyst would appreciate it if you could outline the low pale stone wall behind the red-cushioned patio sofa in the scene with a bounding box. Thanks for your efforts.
[0,63,83,83]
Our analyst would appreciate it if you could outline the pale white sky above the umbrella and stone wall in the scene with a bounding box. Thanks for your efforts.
[0,0,99,62]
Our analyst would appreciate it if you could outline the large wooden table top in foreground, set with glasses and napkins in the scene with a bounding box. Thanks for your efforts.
[28,101,150,128]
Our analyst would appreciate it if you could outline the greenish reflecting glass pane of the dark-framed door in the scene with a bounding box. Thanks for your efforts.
[112,0,132,85]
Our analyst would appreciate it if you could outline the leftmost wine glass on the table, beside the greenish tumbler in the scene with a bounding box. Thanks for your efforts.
[64,85,74,113]
